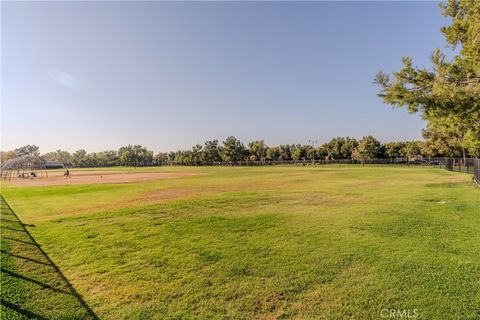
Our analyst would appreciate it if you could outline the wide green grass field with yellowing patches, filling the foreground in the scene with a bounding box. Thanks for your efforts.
[2,166,480,319]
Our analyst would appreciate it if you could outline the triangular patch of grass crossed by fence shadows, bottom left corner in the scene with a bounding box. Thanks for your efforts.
[0,196,98,319]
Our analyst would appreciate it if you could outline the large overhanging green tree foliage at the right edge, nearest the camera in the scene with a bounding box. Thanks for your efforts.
[375,0,480,155]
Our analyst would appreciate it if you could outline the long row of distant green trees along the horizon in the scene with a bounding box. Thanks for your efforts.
[0,136,472,167]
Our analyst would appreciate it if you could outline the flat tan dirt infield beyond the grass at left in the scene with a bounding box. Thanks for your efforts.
[10,170,200,186]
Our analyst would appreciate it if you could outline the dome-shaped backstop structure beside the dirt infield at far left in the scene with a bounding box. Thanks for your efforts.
[0,155,48,180]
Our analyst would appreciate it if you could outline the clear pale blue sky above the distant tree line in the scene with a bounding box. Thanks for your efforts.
[1,2,449,152]
